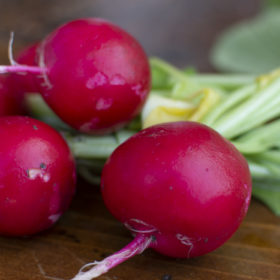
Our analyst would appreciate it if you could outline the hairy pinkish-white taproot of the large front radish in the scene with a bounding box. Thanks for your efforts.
[72,234,154,280]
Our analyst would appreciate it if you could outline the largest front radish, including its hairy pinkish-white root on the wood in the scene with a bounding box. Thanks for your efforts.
[73,122,252,280]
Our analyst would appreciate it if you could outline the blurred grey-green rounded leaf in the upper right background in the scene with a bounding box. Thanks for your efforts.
[210,8,280,74]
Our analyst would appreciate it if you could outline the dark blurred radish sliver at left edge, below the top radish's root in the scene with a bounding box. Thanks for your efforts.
[0,75,22,116]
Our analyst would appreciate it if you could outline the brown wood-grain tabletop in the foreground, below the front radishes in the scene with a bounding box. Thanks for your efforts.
[0,182,280,280]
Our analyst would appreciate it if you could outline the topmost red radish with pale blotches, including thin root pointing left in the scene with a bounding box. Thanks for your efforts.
[0,18,150,133]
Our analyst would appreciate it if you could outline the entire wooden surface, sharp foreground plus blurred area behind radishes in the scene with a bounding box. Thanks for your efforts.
[0,0,280,280]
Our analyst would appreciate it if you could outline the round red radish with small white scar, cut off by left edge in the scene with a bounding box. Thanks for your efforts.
[0,116,76,236]
